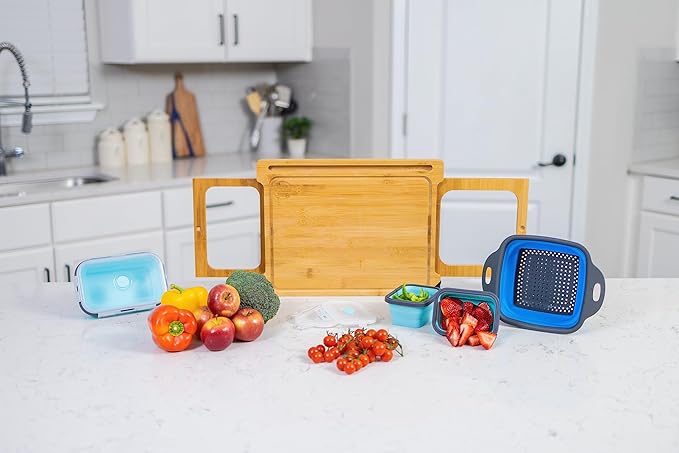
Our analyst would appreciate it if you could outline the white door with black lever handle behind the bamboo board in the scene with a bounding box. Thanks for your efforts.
[394,0,582,264]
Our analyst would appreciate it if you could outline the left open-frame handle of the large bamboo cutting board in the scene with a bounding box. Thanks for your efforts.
[193,178,265,277]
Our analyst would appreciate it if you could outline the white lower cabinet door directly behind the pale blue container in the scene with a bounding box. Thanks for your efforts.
[54,231,165,282]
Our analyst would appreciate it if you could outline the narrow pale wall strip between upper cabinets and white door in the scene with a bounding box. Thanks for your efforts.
[313,0,391,157]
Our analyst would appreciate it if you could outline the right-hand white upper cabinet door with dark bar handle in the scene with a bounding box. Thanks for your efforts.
[225,0,312,61]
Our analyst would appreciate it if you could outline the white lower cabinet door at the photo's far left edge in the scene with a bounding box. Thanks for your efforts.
[0,247,54,297]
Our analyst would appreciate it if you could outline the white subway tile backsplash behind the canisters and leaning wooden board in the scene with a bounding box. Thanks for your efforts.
[0,64,276,172]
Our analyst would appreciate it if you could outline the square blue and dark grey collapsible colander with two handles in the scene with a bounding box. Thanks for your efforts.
[481,235,606,333]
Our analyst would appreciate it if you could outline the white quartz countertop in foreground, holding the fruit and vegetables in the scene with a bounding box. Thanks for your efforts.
[0,279,679,453]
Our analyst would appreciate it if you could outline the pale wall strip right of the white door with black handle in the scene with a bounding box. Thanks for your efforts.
[584,0,679,277]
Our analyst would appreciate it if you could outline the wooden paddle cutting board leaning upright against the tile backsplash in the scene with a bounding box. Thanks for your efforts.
[165,73,205,159]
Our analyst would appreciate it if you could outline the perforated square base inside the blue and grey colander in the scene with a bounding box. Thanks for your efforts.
[514,248,580,315]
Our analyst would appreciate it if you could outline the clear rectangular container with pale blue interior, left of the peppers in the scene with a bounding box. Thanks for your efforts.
[73,253,167,317]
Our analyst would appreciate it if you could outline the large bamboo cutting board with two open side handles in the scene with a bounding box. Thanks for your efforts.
[194,159,527,295]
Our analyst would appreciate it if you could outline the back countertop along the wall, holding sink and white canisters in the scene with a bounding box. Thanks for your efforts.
[0,153,338,207]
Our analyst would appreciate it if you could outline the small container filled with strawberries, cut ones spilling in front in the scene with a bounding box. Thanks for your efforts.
[431,288,500,349]
